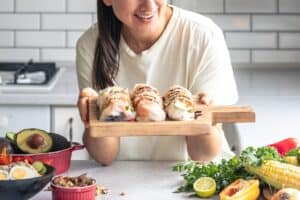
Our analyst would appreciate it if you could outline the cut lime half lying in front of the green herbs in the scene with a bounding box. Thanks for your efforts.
[193,177,217,197]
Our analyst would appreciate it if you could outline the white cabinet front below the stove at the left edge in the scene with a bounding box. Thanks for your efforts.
[0,105,50,137]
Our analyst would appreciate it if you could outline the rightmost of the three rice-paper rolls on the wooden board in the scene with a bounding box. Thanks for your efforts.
[163,85,194,121]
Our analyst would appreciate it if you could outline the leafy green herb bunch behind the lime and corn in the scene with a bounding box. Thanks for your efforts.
[173,147,284,192]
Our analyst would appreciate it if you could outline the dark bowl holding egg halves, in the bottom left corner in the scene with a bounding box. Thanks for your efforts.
[0,164,55,200]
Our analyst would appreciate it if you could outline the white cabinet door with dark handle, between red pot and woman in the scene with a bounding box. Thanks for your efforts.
[51,106,89,160]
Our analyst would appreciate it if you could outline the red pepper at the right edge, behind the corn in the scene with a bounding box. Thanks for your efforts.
[268,138,300,155]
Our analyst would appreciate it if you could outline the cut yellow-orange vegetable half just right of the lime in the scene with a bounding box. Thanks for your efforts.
[219,179,260,200]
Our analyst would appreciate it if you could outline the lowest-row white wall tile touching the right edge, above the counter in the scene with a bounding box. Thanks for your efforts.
[252,50,300,63]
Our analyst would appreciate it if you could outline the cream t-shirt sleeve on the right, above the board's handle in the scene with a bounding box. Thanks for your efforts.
[189,27,238,105]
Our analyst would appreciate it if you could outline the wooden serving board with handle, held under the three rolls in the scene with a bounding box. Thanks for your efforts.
[89,96,255,137]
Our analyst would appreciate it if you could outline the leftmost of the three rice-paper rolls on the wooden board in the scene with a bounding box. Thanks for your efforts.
[97,86,135,121]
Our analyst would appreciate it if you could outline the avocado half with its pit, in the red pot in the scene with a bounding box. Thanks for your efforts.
[15,128,53,154]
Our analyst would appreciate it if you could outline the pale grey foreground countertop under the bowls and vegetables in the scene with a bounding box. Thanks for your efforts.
[32,160,264,200]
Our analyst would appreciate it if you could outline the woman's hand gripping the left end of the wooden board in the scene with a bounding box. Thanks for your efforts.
[77,88,98,128]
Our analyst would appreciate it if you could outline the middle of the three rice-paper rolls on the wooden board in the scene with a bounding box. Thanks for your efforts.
[131,84,166,121]
